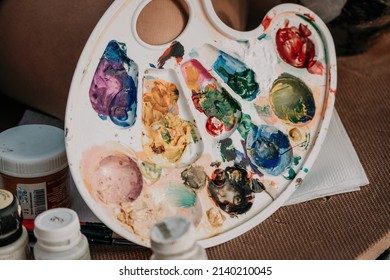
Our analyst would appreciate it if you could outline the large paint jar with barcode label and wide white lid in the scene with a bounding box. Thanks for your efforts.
[0,124,71,219]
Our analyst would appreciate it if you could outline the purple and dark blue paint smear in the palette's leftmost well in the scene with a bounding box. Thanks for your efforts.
[89,41,138,127]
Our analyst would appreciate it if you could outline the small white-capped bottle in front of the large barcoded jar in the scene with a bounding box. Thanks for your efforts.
[33,208,91,260]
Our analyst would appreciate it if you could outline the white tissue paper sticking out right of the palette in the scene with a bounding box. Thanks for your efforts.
[285,110,368,205]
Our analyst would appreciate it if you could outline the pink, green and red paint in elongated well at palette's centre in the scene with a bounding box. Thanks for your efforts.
[181,59,241,136]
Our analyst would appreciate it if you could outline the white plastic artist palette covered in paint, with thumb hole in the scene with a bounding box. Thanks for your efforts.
[66,0,336,247]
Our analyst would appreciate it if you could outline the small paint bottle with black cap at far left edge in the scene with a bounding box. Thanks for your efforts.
[0,189,30,260]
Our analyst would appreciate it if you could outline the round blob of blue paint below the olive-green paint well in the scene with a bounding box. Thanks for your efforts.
[245,125,293,176]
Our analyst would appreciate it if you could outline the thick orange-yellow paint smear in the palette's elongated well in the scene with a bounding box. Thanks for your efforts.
[142,76,198,166]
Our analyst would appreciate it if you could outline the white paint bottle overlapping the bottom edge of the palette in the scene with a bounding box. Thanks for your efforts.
[150,216,208,260]
